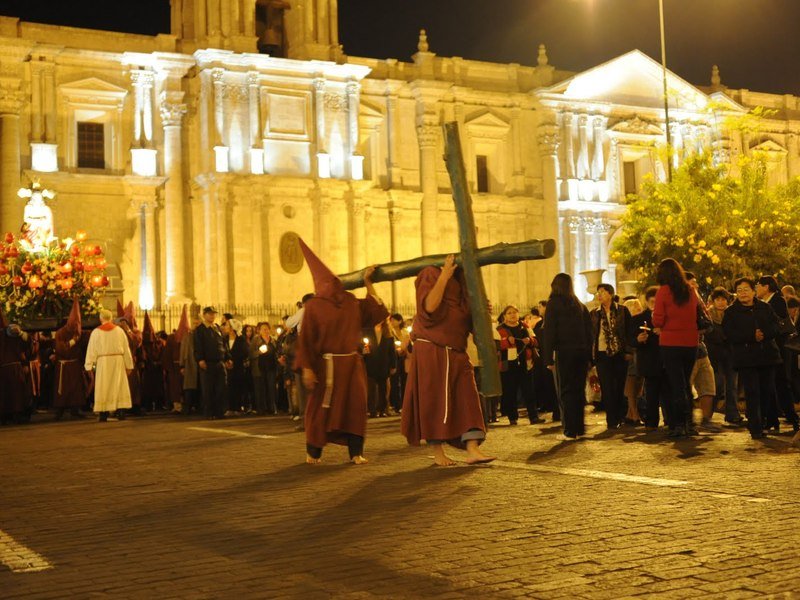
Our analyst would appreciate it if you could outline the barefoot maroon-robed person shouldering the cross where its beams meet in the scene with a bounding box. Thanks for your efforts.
[401,254,494,466]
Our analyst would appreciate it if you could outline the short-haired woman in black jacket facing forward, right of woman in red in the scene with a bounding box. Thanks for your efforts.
[722,277,781,439]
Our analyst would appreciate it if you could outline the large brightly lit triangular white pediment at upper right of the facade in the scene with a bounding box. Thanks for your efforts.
[542,50,709,111]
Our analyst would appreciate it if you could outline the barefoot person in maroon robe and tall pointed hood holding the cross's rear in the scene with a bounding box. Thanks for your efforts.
[294,240,389,465]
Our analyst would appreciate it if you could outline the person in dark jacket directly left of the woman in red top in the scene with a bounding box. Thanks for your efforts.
[628,285,669,431]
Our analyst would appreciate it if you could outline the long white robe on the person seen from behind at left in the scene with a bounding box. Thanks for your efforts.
[85,325,133,412]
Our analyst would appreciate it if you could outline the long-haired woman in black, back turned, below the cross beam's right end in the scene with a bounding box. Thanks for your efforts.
[542,273,593,441]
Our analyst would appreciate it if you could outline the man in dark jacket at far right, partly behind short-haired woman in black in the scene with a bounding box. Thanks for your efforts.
[756,275,800,432]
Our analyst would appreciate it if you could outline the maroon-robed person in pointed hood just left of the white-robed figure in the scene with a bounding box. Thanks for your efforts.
[53,299,86,421]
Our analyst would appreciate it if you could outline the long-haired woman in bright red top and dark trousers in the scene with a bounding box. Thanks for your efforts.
[653,258,700,437]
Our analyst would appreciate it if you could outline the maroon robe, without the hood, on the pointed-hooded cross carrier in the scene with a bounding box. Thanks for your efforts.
[295,292,389,448]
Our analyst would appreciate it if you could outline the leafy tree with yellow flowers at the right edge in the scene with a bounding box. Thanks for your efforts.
[612,154,800,291]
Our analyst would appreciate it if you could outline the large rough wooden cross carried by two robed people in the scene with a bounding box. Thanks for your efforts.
[339,122,556,398]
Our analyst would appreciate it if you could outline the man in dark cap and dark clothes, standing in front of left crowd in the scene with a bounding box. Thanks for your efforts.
[193,306,233,419]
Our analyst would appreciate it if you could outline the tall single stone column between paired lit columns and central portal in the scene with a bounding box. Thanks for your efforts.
[161,92,188,303]
